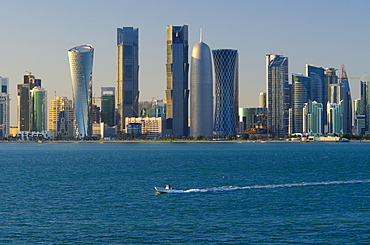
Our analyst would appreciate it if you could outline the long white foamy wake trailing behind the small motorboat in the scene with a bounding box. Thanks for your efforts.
[170,179,370,193]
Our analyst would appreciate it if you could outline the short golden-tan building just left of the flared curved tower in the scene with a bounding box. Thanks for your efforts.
[49,97,76,139]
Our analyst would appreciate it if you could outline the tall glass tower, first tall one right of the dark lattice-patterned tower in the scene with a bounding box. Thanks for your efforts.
[266,54,290,136]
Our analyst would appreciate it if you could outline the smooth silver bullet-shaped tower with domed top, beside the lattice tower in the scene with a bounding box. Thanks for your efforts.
[190,41,213,137]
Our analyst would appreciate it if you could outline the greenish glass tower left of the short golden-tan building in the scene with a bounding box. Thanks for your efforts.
[30,86,47,132]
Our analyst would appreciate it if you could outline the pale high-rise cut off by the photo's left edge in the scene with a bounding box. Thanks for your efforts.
[0,76,10,137]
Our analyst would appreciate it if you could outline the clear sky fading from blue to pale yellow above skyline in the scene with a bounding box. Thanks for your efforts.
[0,0,370,126]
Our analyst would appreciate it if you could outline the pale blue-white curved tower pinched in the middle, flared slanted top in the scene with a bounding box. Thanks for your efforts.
[68,44,94,138]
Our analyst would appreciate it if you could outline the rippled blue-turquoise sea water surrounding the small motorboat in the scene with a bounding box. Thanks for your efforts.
[0,143,370,244]
